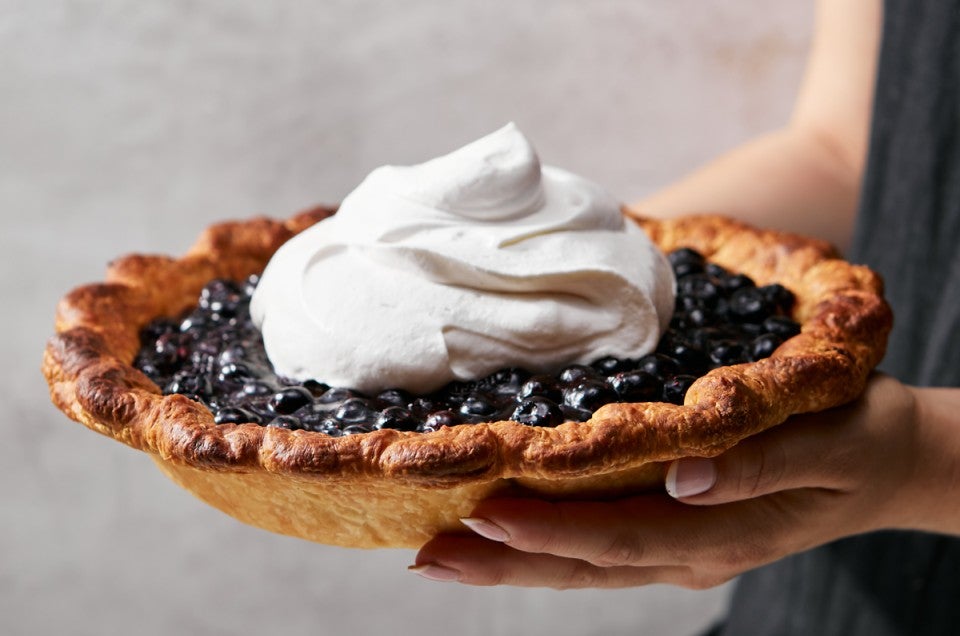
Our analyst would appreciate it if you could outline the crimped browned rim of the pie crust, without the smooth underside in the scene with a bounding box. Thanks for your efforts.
[42,207,892,488]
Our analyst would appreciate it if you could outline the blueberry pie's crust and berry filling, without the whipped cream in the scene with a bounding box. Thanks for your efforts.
[43,204,892,547]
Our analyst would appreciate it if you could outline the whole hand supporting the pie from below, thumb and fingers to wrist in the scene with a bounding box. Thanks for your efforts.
[412,375,942,588]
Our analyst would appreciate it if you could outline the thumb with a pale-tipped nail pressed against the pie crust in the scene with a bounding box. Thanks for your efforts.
[665,414,837,504]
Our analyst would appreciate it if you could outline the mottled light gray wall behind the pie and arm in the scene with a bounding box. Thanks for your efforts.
[0,0,810,636]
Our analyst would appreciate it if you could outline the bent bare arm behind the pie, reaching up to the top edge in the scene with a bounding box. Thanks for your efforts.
[634,0,881,249]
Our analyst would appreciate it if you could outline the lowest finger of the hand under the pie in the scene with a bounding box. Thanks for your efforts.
[410,535,700,589]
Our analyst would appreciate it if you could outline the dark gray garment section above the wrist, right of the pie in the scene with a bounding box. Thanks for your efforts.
[851,0,960,386]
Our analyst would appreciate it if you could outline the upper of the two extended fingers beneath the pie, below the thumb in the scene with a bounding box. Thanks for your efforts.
[432,495,805,575]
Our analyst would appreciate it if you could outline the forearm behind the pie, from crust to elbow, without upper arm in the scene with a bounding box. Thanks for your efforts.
[633,126,860,250]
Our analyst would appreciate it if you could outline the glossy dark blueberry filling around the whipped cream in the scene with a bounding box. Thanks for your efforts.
[134,249,800,436]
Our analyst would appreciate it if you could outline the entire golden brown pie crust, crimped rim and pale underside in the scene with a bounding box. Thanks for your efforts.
[43,208,892,546]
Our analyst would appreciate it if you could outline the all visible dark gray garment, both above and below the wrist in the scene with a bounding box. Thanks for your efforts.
[718,0,960,636]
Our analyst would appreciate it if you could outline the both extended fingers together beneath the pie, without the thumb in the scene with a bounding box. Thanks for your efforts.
[414,492,816,589]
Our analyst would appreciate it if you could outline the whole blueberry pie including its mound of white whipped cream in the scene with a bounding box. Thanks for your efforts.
[43,126,892,547]
